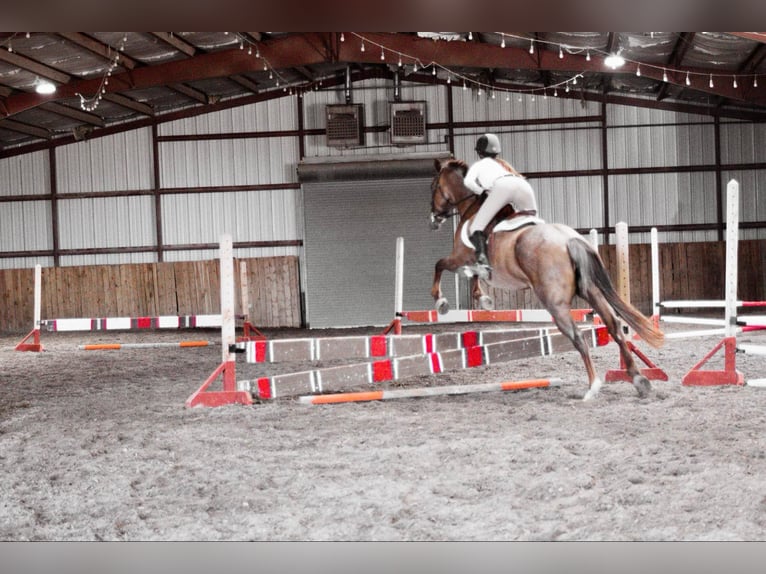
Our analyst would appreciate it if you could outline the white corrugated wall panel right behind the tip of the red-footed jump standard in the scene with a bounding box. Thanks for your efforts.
[162,189,302,246]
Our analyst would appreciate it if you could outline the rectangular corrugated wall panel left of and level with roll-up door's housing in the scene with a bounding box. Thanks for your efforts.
[160,137,298,188]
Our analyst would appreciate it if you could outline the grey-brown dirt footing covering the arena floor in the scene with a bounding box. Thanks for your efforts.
[0,330,766,541]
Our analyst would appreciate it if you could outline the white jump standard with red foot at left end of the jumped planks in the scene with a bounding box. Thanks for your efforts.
[186,234,253,407]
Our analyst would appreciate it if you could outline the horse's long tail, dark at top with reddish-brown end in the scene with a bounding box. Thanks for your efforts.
[567,237,665,348]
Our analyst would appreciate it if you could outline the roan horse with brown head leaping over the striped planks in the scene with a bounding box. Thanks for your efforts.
[431,159,665,401]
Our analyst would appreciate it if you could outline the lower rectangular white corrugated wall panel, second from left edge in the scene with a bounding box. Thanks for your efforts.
[58,196,156,251]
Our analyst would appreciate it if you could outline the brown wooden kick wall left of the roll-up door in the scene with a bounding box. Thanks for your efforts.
[0,256,301,332]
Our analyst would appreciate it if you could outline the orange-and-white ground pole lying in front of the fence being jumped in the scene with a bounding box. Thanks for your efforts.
[298,379,561,405]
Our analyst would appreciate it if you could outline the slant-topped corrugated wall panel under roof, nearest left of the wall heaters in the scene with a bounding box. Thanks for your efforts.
[158,100,298,136]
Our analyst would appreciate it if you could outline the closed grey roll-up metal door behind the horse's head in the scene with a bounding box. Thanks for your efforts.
[303,177,457,328]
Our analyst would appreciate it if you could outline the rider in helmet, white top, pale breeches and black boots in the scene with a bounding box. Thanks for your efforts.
[465,134,537,269]
